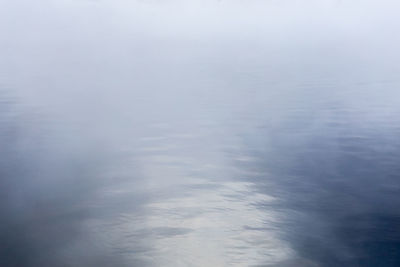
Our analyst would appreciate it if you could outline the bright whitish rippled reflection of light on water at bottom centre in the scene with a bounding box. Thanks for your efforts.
[95,181,293,266]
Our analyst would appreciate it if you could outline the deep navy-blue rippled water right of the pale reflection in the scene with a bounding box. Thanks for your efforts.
[240,102,400,266]
